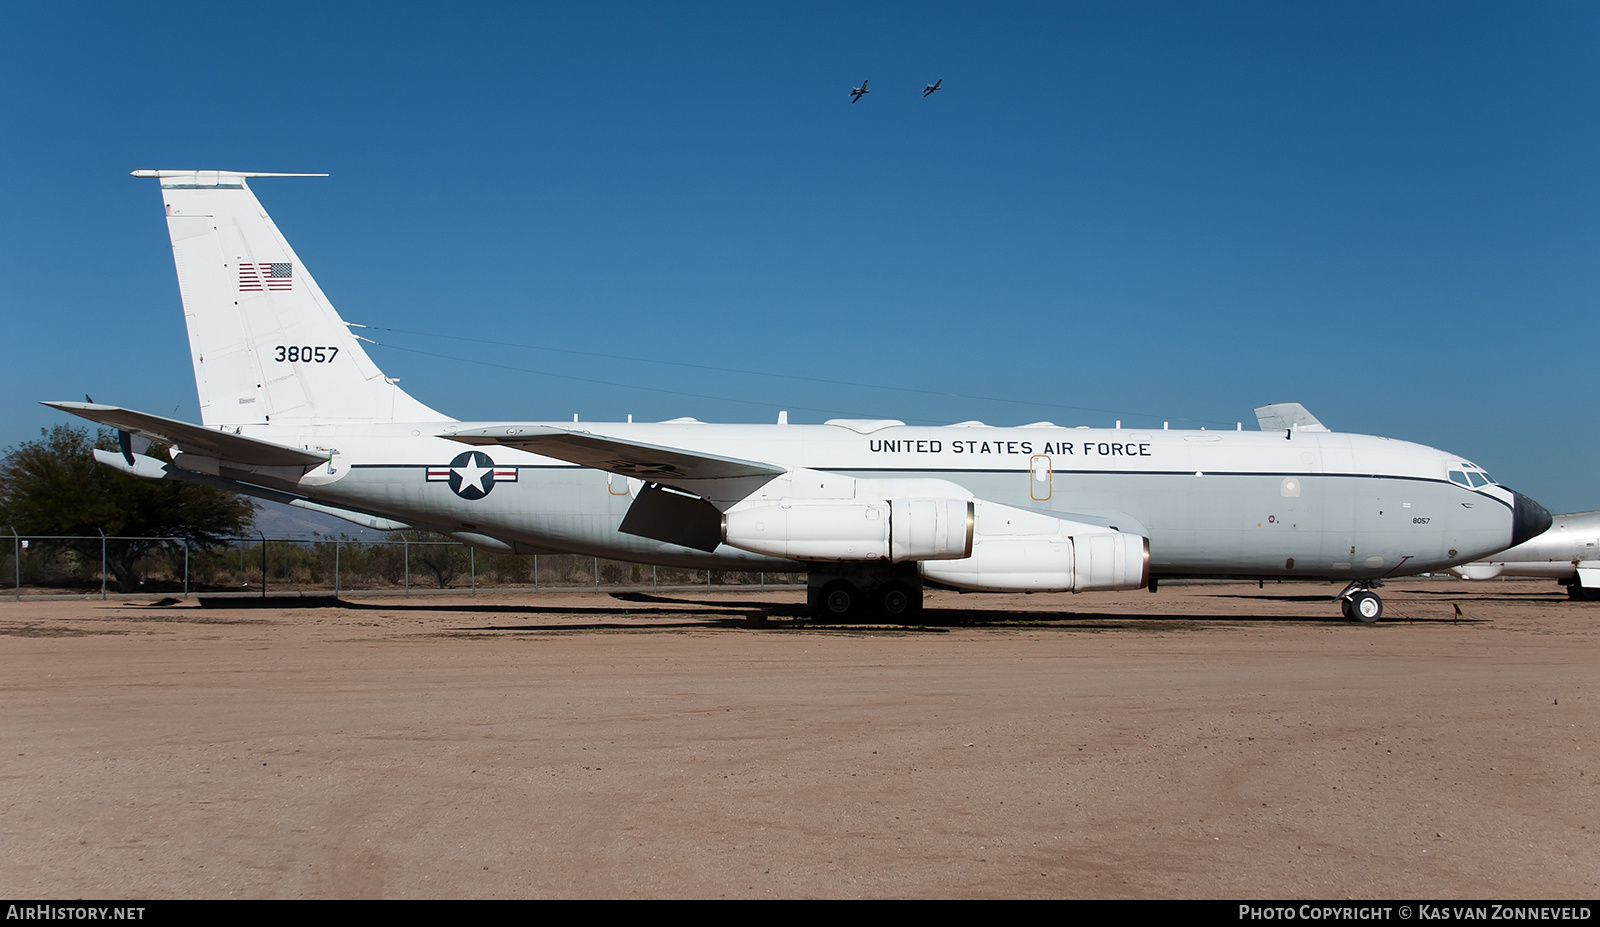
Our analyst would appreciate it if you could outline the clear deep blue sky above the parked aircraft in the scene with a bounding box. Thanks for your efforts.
[0,2,1600,511]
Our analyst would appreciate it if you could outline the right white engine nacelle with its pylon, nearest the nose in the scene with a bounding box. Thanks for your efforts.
[920,501,1150,592]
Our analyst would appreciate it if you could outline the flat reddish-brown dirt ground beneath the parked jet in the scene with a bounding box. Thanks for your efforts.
[0,581,1600,900]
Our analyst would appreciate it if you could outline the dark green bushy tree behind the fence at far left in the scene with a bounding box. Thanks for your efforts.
[0,424,256,589]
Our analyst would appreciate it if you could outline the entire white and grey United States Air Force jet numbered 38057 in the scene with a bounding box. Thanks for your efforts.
[48,171,1550,621]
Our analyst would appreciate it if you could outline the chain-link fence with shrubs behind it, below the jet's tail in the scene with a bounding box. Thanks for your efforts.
[0,533,805,599]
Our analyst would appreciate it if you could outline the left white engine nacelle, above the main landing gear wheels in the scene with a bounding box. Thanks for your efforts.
[722,498,974,564]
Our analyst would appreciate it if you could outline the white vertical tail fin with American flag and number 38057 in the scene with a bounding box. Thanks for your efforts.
[133,171,448,426]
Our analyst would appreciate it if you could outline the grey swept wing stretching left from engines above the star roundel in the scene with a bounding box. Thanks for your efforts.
[440,424,789,482]
